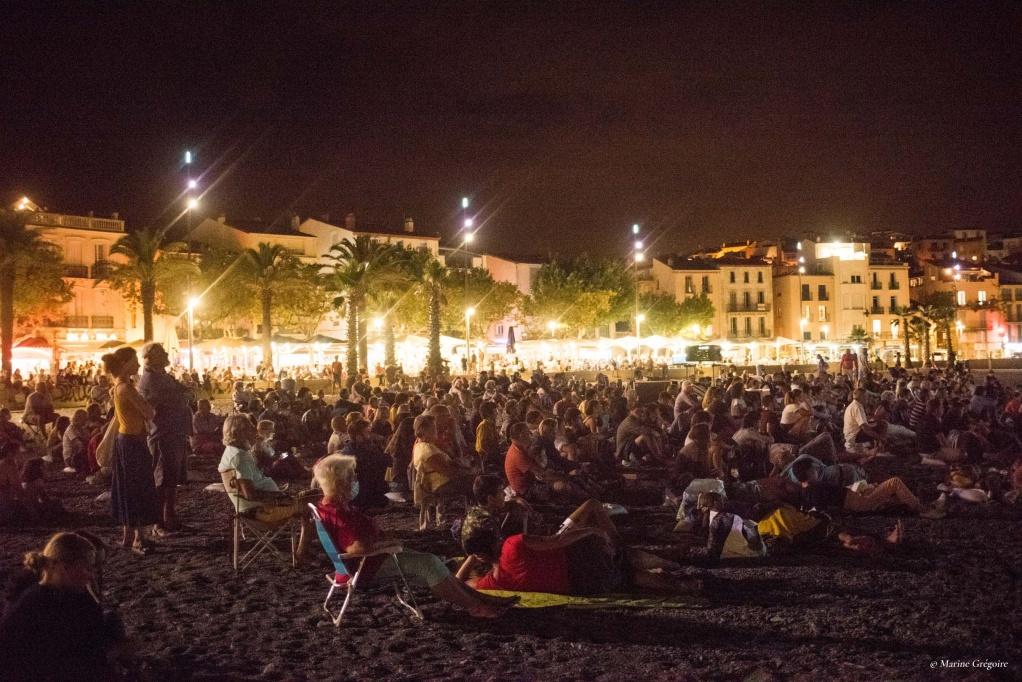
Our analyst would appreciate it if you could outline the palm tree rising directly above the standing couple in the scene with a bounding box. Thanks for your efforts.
[96,228,199,342]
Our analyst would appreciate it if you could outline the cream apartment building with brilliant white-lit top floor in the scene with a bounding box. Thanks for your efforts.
[774,240,910,355]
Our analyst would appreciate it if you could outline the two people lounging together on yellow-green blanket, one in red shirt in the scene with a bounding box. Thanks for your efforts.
[458,475,693,595]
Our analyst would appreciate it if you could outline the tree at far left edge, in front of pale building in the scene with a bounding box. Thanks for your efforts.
[0,209,71,374]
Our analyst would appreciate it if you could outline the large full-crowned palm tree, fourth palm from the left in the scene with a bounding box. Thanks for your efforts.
[325,235,403,381]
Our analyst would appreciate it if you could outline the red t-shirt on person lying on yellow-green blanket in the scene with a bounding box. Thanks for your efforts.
[475,534,571,594]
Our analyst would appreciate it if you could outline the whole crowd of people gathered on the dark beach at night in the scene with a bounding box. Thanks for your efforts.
[0,344,1022,678]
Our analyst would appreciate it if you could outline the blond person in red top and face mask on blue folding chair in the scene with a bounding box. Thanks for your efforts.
[313,455,517,618]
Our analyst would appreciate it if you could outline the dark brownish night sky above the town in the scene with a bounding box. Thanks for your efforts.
[0,1,1022,258]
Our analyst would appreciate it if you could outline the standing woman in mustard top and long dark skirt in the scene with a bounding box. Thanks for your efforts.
[103,348,159,555]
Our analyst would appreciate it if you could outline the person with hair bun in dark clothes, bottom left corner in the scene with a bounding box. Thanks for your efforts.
[0,533,125,681]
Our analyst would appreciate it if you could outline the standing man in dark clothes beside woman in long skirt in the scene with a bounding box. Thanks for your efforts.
[138,343,192,535]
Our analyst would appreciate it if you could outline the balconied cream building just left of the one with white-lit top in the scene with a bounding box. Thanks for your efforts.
[652,256,774,343]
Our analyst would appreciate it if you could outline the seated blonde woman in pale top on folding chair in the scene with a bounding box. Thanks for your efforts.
[217,414,312,559]
